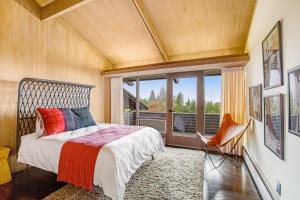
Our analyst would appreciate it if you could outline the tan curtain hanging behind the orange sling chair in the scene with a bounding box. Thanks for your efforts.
[220,67,246,155]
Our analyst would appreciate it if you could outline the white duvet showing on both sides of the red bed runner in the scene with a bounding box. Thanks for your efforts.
[18,124,164,199]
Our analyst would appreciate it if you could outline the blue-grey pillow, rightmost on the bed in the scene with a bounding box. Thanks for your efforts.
[71,108,96,129]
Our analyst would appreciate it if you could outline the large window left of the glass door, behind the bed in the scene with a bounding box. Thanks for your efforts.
[123,76,167,134]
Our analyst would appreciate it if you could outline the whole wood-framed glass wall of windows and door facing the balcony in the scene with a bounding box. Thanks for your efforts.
[123,71,221,148]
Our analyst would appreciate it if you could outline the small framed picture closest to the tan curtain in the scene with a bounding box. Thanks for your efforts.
[249,84,262,122]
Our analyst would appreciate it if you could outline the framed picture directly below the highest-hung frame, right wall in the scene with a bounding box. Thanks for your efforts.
[264,94,284,160]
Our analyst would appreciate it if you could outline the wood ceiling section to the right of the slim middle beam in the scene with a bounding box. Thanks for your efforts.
[137,0,255,57]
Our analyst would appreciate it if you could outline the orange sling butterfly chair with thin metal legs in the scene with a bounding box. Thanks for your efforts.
[197,114,252,168]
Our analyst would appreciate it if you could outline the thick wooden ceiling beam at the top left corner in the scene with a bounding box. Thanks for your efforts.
[42,0,93,21]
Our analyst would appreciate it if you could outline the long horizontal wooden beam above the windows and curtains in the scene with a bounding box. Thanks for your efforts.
[102,53,249,76]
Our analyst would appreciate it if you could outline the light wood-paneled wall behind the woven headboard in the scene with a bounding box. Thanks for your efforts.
[0,0,110,171]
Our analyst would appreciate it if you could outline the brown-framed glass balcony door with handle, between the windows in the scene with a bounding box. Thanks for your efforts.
[167,72,204,148]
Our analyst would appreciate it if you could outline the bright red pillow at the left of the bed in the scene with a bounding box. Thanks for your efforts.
[37,108,65,135]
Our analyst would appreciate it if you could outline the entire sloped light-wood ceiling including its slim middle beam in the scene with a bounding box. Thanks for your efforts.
[36,0,256,68]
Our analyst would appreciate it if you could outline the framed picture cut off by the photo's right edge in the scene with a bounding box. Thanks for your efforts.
[288,65,300,137]
